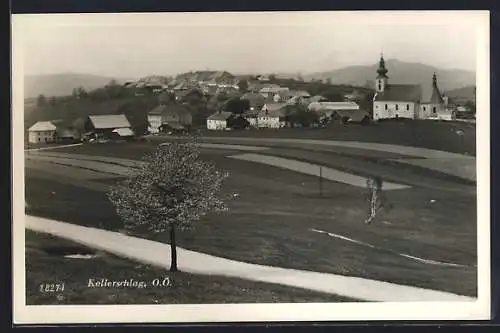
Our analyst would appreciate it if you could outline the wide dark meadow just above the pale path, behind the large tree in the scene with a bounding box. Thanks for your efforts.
[26,141,476,295]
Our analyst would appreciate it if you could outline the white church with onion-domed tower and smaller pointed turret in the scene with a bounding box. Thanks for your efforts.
[373,56,454,121]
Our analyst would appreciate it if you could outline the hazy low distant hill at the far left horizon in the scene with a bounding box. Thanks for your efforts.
[24,73,134,98]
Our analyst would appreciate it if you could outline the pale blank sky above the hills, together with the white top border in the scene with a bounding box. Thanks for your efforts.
[13,12,488,78]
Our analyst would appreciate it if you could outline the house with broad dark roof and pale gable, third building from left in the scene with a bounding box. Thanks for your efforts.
[148,104,193,133]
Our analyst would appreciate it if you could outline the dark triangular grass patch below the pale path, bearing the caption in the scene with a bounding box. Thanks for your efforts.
[26,231,349,305]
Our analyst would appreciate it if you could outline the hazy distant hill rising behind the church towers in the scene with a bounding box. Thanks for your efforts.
[303,59,476,101]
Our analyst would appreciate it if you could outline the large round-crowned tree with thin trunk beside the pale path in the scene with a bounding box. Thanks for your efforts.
[108,137,228,272]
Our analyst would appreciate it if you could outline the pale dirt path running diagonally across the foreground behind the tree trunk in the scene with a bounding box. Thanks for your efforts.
[25,216,475,302]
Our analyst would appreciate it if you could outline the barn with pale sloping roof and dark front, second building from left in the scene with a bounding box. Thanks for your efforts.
[84,114,134,139]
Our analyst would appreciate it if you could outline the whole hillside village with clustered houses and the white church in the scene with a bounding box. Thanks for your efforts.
[28,56,470,144]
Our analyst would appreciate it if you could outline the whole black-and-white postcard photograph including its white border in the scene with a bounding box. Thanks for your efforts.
[12,11,490,324]
